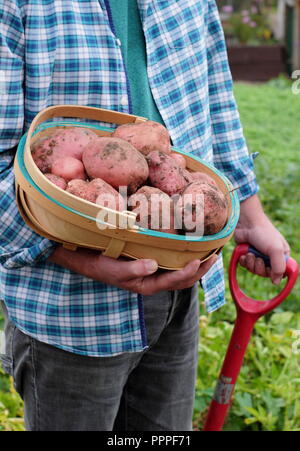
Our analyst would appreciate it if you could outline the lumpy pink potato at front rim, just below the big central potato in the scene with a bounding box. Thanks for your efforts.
[67,179,126,211]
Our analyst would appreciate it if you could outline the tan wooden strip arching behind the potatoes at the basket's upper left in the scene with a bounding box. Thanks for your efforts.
[25,105,148,154]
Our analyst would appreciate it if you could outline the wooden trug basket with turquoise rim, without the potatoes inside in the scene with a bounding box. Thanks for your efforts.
[14,105,240,270]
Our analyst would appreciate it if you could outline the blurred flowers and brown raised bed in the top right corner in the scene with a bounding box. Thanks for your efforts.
[217,0,300,81]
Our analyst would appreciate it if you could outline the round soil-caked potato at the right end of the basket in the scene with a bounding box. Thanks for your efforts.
[175,181,228,235]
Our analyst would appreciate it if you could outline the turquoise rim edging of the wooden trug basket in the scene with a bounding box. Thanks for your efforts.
[16,120,240,242]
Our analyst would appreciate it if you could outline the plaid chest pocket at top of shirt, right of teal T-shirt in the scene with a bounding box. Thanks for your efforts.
[148,0,204,50]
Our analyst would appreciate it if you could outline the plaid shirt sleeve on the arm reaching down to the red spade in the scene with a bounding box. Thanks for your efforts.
[206,0,258,201]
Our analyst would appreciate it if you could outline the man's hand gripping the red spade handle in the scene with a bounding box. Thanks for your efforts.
[234,195,290,285]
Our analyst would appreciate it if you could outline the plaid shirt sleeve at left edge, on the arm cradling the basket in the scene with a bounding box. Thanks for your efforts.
[0,0,55,269]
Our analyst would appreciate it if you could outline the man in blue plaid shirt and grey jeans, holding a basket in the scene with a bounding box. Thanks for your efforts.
[0,0,289,431]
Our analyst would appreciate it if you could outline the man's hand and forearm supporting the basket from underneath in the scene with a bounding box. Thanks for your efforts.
[49,246,217,295]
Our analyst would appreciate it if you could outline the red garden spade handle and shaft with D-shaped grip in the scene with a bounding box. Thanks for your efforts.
[203,244,299,431]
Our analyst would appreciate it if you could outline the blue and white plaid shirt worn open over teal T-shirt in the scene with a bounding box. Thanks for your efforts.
[0,0,258,356]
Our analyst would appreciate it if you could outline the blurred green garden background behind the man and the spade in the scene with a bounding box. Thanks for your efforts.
[0,0,300,431]
